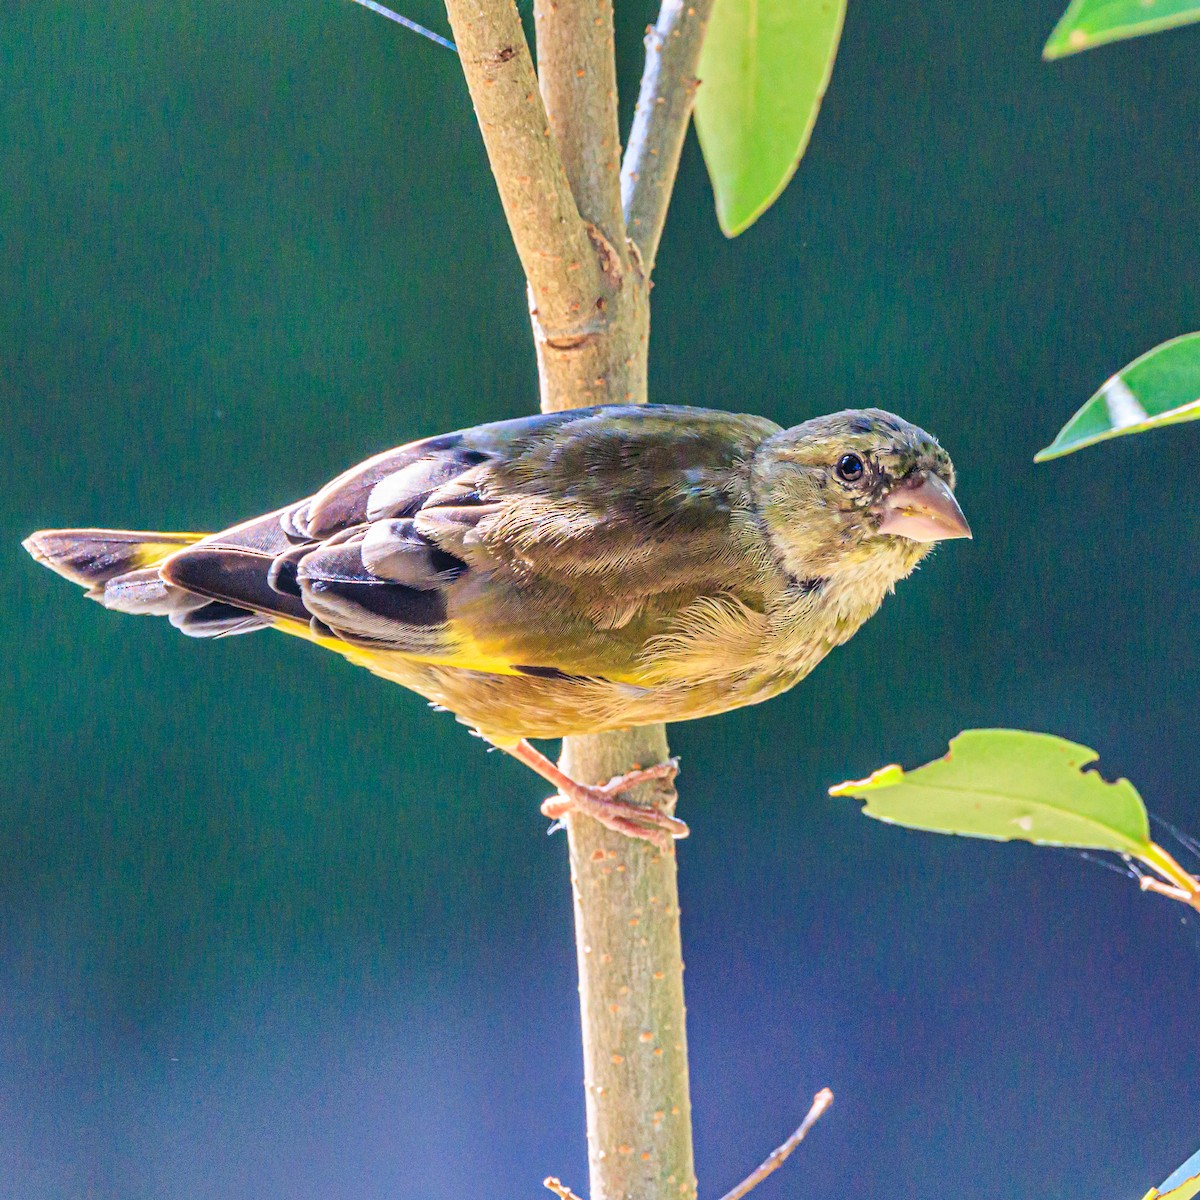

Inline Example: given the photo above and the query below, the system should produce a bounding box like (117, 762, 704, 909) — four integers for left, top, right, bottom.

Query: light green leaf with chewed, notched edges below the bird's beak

(829, 730, 1151, 857)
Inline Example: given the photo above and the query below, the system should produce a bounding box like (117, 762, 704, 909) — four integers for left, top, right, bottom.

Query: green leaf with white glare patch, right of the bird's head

(1033, 334, 1200, 462)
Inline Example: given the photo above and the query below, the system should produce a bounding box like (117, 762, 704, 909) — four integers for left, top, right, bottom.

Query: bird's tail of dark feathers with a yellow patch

(22, 529, 273, 637)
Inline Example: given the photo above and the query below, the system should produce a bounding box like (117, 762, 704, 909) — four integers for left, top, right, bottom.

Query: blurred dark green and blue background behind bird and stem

(0, 0, 1200, 1200)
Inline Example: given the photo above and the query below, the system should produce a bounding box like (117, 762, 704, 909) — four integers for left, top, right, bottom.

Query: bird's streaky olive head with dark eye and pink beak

(754, 408, 971, 586)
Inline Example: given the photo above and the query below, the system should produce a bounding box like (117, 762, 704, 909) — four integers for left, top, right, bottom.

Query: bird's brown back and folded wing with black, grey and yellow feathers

(163, 406, 778, 674)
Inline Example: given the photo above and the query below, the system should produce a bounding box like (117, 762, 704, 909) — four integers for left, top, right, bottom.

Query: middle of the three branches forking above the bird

(533, 0, 626, 253)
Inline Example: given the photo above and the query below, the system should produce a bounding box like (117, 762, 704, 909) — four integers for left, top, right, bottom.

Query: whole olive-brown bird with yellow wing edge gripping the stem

(24, 404, 971, 851)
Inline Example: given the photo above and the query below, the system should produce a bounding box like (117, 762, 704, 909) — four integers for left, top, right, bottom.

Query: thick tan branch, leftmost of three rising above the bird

(446, 0, 612, 338)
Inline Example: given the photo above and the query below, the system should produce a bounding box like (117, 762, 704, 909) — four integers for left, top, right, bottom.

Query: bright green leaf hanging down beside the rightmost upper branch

(696, 0, 846, 238)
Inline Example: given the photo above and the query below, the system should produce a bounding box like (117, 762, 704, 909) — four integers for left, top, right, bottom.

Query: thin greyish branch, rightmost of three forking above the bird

(620, 0, 713, 275)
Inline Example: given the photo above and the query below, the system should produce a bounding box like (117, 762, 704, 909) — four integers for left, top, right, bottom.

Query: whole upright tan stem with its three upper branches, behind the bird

(436, 0, 712, 1200)
